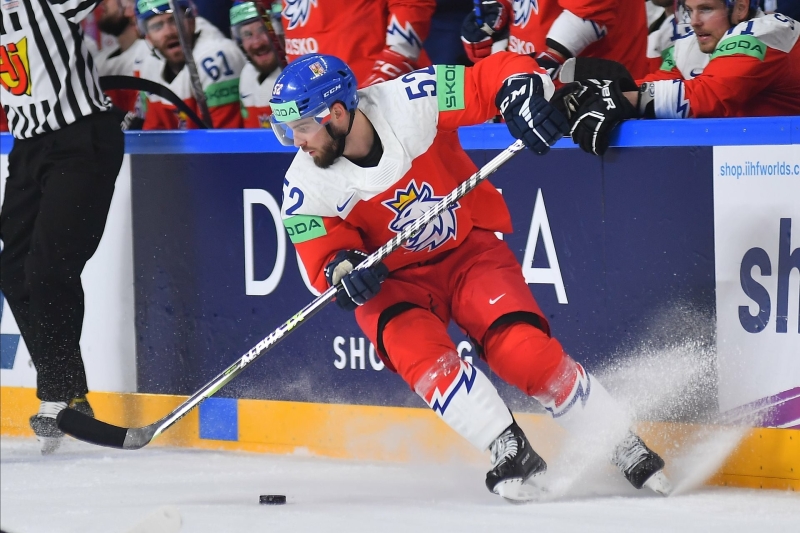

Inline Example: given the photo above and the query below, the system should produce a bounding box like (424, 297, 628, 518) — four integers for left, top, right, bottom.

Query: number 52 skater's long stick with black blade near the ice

(57, 137, 524, 450)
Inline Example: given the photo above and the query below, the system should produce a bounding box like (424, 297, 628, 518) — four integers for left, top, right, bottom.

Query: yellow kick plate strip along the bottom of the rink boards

(0, 387, 800, 491)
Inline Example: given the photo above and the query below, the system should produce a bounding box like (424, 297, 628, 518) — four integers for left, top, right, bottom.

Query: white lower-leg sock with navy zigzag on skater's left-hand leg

(414, 350, 514, 451)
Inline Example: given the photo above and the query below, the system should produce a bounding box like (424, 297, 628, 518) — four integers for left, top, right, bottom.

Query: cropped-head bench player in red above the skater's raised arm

(461, 0, 648, 79)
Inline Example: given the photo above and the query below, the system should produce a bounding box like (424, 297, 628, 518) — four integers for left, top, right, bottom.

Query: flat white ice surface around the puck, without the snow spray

(0, 438, 800, 533)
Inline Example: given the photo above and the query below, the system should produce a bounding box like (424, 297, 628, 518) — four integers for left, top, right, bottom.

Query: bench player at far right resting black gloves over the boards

(555, 0, 800, 154)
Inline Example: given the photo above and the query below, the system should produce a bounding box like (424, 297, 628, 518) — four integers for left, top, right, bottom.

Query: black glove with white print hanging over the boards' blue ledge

(550, 79, 638, 155)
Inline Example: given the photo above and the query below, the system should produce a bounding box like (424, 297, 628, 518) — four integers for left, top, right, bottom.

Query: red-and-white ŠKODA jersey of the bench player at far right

(644, 13, 800, 118)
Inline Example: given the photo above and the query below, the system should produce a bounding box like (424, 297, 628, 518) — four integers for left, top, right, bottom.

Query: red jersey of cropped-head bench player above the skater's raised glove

(501, 0, 648, 78)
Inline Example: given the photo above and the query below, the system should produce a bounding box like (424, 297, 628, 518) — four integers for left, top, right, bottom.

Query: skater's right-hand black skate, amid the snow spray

(612, 433, 672, 496)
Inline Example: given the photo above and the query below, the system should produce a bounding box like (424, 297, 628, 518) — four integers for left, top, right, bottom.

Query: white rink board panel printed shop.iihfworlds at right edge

(714, 145, 800, 411)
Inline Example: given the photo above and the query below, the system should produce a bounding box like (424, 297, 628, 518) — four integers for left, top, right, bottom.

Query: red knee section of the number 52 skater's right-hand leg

(484, 322, 567, 396)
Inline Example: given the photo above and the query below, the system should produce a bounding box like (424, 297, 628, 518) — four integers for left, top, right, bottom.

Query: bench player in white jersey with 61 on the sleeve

(136, 0, 247, 130)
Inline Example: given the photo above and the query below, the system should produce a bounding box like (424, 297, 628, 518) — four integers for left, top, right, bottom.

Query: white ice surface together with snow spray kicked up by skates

(0, 309, 800, 533)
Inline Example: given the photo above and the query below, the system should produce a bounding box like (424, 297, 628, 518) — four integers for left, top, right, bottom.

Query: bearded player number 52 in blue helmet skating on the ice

(270, 52, 666, 501)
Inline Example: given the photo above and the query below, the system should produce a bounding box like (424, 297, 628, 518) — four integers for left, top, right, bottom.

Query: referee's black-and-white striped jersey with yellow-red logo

(0, 0, 111, 139)
